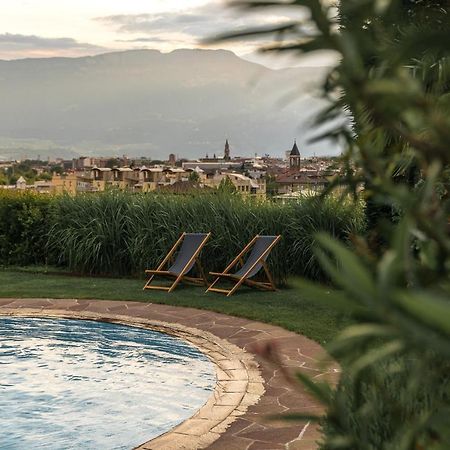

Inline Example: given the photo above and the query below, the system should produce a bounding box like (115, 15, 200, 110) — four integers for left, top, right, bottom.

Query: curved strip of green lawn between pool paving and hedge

(0, 269, 350, 344)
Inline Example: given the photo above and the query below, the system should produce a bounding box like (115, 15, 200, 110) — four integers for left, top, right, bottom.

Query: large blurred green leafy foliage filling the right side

(220, 0, 450, 450)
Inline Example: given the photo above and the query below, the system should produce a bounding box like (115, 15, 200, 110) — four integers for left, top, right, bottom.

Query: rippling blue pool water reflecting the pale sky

(0, 317, 216, 450)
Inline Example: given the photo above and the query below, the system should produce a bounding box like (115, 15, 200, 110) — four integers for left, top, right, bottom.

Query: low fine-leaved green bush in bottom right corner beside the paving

(321, 357, 450, 450)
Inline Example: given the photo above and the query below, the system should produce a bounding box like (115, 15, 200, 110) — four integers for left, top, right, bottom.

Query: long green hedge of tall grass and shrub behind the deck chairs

(0, 190, 364, 282)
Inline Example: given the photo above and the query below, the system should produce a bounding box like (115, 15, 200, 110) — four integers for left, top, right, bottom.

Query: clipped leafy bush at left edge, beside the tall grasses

(0, 190, 51, 265)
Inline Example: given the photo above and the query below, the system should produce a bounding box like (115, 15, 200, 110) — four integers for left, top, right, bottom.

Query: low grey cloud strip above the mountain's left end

(0, 33, 107, 57)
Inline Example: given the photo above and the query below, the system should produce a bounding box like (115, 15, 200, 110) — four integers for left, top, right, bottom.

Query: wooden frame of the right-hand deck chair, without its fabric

(206, 234, 281, 297)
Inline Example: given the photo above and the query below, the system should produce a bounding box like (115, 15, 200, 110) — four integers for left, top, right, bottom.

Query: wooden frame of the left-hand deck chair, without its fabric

(143, 233, 211, 292)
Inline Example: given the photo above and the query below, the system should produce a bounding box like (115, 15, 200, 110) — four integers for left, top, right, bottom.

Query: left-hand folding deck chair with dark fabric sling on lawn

(144, 233, 211, 292)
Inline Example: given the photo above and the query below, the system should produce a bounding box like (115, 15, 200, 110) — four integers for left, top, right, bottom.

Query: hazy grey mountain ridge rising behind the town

(0, 50, 336, 159)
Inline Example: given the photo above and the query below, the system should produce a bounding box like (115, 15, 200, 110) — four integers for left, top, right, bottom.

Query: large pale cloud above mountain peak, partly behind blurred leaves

(94, 0, 334, 68)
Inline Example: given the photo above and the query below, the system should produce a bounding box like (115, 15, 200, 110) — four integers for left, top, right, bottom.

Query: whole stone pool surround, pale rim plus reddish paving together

(0, 299, 339, 450)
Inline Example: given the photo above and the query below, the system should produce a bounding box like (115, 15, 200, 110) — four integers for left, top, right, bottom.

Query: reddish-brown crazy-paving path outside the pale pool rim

(0, 299, 338, 450)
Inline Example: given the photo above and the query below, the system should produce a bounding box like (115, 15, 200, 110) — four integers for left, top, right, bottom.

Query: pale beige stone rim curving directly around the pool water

(0, 308, 265, 450)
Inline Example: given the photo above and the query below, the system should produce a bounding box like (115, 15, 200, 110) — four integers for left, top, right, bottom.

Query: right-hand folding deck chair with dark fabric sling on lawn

(206, 235, 281, 297)
